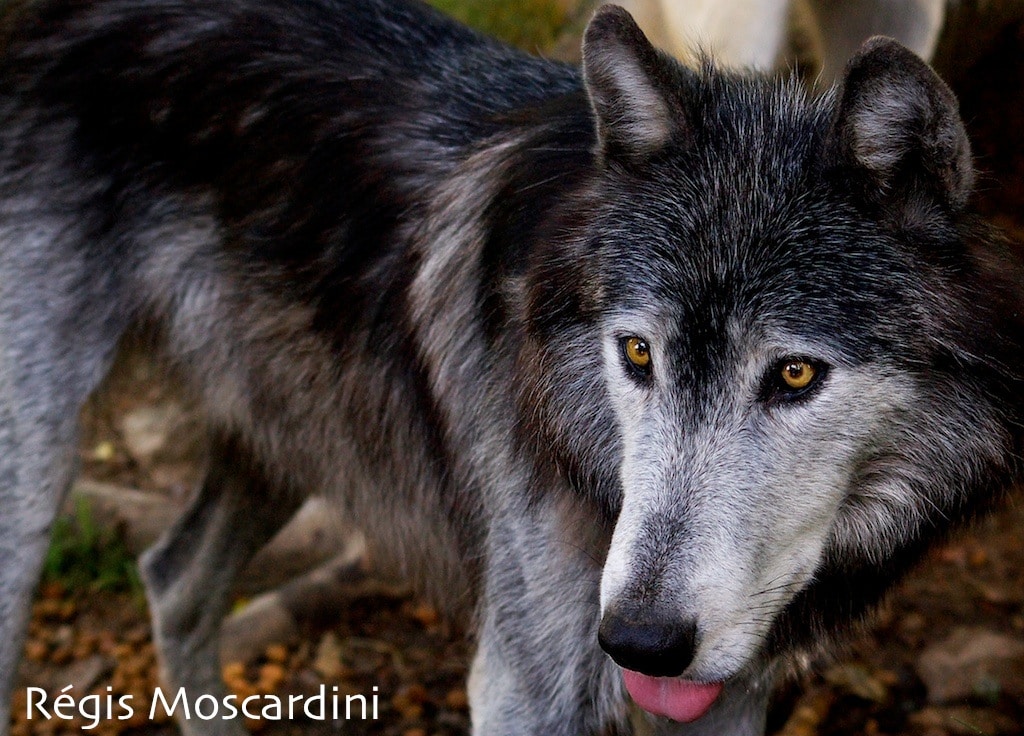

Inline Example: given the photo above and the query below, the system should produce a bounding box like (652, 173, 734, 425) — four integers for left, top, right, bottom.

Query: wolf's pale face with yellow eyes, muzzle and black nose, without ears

(601, 195, 927, 681)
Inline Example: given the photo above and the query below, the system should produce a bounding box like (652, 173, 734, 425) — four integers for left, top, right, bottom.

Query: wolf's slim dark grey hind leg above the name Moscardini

(140, 431, 301, 735)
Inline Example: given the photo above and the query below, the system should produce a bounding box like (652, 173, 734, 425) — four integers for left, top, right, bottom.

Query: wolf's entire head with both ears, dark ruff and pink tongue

(520, 2, 1020, 719)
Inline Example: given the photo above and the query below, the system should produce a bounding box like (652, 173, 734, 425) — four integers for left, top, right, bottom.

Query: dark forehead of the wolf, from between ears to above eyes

(598, 82, 915, 359)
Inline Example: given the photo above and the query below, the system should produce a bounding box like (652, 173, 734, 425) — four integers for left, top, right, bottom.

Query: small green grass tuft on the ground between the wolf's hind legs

(43, 499, 142, 598)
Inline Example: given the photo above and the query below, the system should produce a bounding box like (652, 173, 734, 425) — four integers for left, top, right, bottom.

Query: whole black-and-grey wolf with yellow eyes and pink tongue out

(0, 0, 1024, 736)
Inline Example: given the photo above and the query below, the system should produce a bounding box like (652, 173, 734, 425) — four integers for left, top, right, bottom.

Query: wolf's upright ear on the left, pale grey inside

(583, 5, 683, 161)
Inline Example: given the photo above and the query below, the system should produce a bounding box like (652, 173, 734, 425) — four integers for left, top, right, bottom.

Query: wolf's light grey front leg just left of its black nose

(469, 510, 626, 736)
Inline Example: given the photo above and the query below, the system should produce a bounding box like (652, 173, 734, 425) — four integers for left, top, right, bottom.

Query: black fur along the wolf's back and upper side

(4, 1, 588, 331)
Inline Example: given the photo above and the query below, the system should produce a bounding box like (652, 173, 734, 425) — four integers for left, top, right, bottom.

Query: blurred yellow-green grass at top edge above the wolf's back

(429, 0, 569, 51)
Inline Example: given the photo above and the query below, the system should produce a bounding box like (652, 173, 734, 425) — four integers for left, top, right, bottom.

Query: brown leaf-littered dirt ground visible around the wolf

(13, 12, 1024, 736)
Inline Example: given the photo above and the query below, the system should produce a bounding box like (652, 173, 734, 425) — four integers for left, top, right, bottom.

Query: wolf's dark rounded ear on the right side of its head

(831, 36, 974, 210)
